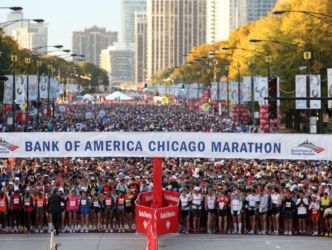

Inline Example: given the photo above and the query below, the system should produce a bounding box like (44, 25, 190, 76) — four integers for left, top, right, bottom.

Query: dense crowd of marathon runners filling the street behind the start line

(0, 104, 332, 237)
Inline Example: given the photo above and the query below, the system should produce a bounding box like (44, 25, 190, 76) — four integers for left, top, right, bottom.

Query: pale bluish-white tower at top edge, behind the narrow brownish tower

(121, 0, 146, 43)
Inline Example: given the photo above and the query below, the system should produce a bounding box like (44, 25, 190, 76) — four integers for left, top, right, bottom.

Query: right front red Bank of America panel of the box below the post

(156, 206, 179, 236)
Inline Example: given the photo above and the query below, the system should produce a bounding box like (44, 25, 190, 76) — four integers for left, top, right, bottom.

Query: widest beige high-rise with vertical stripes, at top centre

(147, 0, 206, 77)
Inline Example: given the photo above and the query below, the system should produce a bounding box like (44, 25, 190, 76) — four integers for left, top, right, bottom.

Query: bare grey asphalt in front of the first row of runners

(0, 233, 332, 250)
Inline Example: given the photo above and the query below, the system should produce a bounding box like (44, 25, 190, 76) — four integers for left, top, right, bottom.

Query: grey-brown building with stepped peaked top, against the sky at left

(72, 26, 118, 66)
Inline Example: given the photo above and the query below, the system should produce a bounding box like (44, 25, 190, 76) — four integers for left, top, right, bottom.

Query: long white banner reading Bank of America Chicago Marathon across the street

(0, 132, 332, 160)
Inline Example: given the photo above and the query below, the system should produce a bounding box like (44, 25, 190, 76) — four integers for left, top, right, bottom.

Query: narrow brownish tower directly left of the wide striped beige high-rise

(135, 11, 147, 87)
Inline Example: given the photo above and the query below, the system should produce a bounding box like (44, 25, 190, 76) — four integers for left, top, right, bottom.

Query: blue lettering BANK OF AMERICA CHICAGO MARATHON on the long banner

(25, 140, 281, 154)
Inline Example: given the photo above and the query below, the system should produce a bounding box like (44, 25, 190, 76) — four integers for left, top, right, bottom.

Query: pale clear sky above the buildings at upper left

(0, 0, 121, 50)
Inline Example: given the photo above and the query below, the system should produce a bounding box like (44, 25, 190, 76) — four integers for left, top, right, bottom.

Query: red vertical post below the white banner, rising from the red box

(153, 157, 163, 209)
